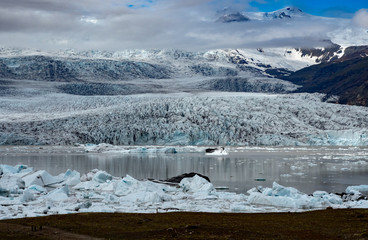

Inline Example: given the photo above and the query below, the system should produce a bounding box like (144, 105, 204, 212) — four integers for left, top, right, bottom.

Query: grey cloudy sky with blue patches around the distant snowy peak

(0, 0, 368, 50)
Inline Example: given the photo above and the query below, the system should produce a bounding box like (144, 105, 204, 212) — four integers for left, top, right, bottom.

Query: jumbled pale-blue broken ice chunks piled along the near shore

(0, 165, 368, 219)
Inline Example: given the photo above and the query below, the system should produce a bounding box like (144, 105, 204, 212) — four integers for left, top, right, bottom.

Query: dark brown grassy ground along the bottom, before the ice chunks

(0, 209, 368, 239)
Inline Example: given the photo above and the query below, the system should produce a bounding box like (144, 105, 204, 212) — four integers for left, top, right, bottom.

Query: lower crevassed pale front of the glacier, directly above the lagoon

(0, 92, 368, 145)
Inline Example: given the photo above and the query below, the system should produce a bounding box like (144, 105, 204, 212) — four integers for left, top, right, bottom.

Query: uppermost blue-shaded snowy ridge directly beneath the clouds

(0, 45, 348, 82)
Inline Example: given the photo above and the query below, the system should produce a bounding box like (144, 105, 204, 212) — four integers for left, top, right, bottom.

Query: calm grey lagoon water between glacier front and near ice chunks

(0, 149, 368, 193)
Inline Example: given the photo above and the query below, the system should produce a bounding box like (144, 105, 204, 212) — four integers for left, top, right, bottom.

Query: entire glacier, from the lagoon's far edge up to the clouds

(0, 44, 368, 146)
